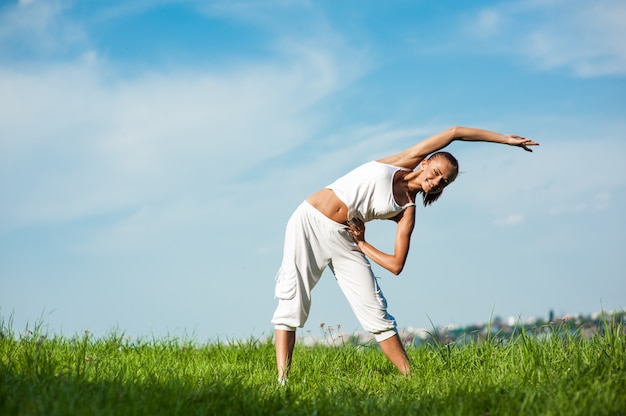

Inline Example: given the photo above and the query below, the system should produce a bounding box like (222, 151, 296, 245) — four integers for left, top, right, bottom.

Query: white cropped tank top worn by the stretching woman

(326, 162, 415, 222)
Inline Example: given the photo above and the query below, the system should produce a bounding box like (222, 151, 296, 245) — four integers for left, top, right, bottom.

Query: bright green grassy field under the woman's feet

(0, 316, 626, 415)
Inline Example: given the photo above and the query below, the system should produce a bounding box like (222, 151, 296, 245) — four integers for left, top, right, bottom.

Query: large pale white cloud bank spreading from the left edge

(0, 41, 360, 234)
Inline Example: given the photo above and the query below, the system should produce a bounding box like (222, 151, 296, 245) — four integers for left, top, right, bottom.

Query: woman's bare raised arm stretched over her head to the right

(378, 126, 539, 170)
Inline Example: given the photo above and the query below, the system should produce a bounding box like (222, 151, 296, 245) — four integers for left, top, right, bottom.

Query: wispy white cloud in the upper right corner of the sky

(468, 0, 626, 77)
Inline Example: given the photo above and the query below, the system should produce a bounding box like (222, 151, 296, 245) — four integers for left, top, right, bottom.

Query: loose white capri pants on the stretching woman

(272, 201, 397, 342)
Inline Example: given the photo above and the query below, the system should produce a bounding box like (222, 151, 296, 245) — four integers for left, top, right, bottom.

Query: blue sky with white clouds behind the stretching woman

(0, 0, 626, 341)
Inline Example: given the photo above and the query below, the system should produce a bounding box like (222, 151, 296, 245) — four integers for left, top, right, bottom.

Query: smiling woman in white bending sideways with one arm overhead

(272, 127, 538, 383)
